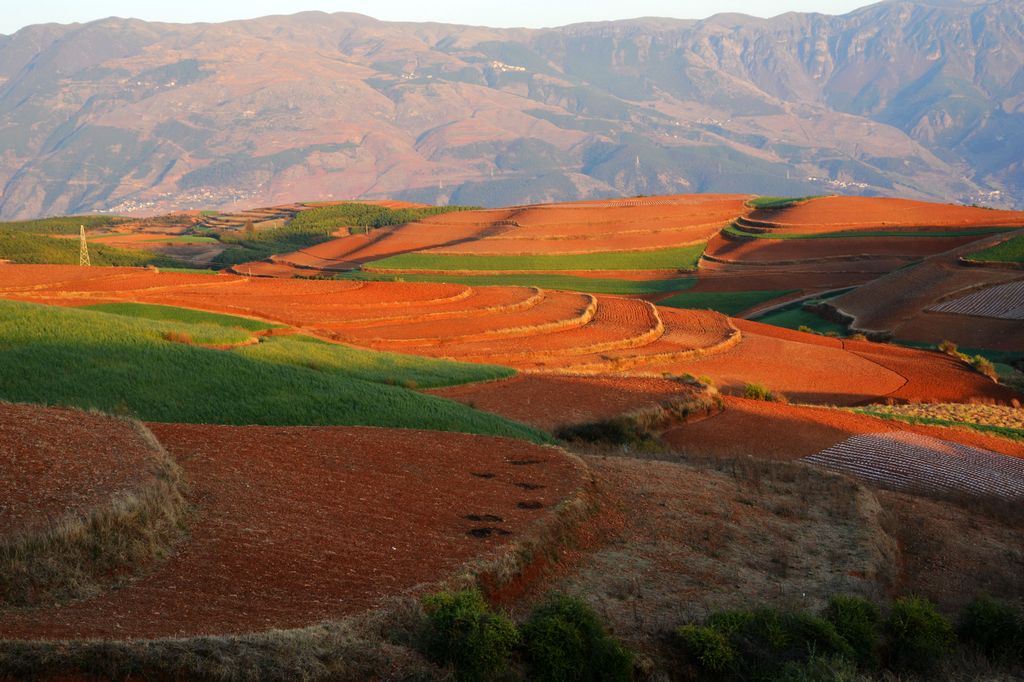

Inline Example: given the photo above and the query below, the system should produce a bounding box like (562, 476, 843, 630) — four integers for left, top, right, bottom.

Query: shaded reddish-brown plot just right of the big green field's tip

(429, 374, 689, 430)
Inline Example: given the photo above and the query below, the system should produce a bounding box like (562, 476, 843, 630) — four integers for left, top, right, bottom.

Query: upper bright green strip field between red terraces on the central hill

(366, 244, 705, 271)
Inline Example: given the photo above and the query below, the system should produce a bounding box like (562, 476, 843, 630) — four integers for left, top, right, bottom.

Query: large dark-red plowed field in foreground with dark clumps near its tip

(0, 424, 581, 639)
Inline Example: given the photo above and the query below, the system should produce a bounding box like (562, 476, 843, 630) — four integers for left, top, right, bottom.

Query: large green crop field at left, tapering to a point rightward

(0, 301, 550, 442)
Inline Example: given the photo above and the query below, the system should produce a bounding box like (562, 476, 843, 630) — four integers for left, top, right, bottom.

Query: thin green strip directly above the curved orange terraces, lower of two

(336, 270, 696, 296)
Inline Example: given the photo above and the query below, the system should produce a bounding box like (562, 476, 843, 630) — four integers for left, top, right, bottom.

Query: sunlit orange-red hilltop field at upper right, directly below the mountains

(751, 197, 1024, 233)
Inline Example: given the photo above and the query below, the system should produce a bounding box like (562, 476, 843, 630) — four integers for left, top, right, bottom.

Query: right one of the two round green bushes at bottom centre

(522, 596, 633, 682)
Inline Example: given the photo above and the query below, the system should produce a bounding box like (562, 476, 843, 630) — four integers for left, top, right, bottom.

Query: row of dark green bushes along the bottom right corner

(675, 595, 1024, 680)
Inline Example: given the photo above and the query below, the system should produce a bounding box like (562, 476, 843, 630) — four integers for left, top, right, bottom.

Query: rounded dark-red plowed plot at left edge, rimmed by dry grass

(0, 402, 156, 537)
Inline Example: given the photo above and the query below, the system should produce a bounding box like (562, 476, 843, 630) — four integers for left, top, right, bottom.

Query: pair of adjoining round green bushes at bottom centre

(418, 590, 633, 682)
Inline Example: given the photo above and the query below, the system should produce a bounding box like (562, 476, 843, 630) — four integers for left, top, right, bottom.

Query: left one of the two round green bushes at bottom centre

(423, 590, 519, 680)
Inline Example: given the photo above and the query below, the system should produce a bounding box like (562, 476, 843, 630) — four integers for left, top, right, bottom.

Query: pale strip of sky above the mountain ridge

(0, 0, 872, 34)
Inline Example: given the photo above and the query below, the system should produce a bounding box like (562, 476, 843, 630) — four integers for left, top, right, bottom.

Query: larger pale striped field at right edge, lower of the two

(803, 433, 1024, 500)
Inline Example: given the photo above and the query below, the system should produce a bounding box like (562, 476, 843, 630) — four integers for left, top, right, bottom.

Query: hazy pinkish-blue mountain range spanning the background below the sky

(0, 0, 1024, 218)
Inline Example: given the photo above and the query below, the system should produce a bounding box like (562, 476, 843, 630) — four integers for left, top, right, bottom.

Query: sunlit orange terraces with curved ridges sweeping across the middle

(0, 266, 1012, 404)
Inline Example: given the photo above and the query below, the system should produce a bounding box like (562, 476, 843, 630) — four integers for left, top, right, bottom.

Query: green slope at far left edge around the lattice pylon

(0, 230, 181, 267)
